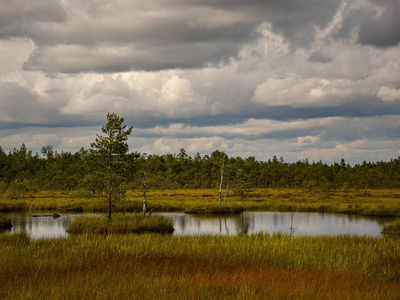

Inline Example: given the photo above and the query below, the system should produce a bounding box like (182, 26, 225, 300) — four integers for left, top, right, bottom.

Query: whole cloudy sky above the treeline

(0, 0, 400, 164)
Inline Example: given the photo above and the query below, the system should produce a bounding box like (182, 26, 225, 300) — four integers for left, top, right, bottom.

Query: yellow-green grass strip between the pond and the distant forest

(0, 189, 400, 217)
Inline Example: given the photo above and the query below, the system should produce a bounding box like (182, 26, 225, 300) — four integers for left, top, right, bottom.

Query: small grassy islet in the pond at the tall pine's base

(67, 215, 174, 234)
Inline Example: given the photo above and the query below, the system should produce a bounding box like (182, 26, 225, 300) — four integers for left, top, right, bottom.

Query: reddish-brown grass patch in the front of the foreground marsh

(0, 258, 400, 299)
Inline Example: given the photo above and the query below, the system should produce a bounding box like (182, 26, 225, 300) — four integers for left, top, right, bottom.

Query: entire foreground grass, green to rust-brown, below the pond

(0, 233, 400, 299)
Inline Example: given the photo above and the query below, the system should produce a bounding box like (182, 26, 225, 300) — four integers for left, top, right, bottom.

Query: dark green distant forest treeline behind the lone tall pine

(0, 144, 400, 198)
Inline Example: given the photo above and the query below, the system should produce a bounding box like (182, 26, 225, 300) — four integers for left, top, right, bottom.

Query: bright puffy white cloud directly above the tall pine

(60, 72, 208, 118)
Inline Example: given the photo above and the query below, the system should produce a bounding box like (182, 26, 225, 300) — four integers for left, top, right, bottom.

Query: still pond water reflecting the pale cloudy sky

(4, 212, 390, 239)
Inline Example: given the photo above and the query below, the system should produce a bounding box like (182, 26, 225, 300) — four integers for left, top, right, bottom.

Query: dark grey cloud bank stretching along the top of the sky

(0, 0, 400, 73)
